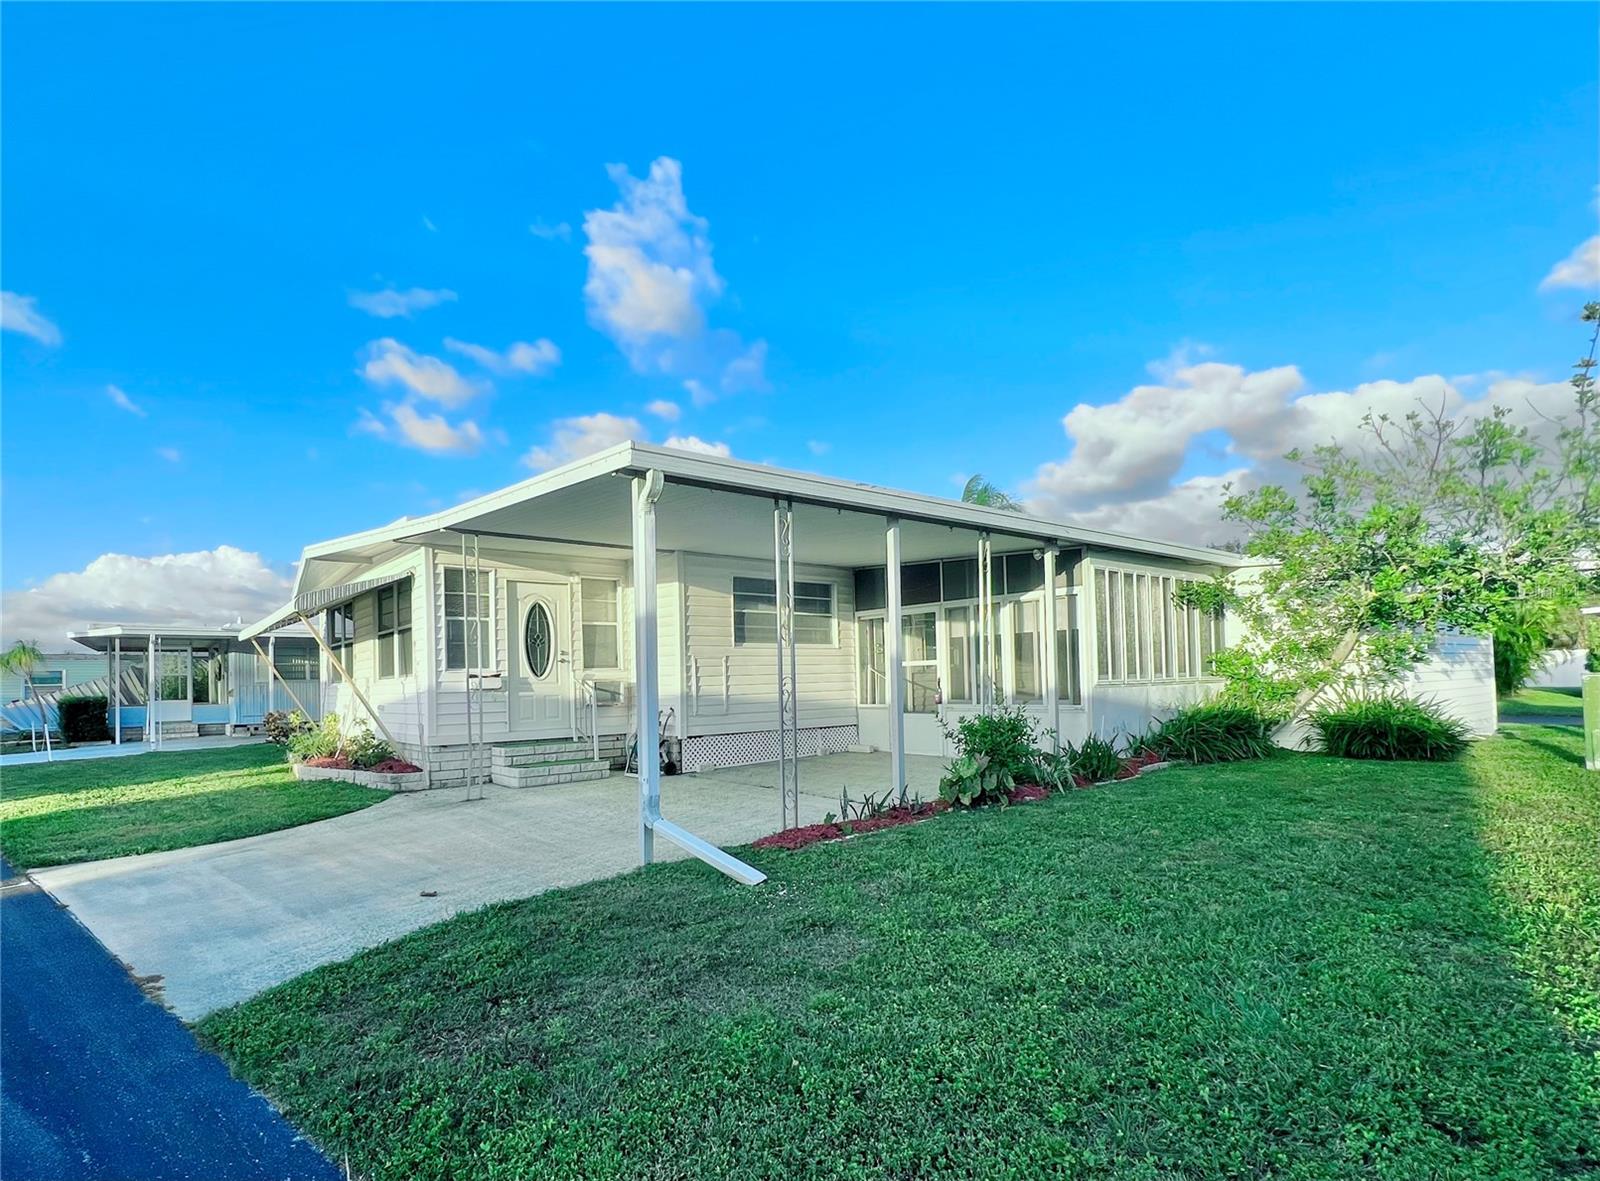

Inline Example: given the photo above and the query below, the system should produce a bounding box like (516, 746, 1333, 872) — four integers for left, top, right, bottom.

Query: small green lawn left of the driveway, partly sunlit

(0, 744, 386, 869)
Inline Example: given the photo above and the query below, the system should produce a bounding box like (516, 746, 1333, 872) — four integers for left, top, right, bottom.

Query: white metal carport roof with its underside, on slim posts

(281, 443, 1240, 608)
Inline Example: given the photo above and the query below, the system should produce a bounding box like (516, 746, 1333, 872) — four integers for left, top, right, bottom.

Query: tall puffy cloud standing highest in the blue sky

(584, 157, 766, 397)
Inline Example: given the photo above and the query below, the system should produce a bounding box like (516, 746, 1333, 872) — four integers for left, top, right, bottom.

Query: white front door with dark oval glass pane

(506, 581, 573, 738)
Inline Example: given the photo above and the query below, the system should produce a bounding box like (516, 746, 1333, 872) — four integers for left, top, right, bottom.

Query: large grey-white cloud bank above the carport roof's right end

(1024, 352, 1571, 542)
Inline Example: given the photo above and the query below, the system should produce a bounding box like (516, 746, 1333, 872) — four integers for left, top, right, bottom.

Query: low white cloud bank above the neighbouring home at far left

(0, 546, 290, 651)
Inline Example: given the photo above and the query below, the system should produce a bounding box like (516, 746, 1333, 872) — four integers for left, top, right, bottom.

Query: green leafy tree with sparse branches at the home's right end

(1192, 304, 1600, 717)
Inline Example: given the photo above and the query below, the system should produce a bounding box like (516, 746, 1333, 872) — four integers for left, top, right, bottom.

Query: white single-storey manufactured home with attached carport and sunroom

(243, 443, 1238, 787)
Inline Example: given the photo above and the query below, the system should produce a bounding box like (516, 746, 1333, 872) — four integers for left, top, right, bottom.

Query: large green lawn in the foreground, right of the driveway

(200, 727, 1600, 1181)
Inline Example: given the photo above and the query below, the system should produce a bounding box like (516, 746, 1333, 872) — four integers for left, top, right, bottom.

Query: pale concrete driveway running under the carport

(34, 755, 939, 1021)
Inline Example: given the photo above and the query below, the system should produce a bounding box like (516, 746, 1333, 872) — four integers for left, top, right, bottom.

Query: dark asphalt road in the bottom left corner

(0, 861, 342, 1181)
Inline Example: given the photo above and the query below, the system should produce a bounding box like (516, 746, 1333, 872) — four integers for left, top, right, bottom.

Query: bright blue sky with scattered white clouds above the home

(0, 5, 1600, 634)
